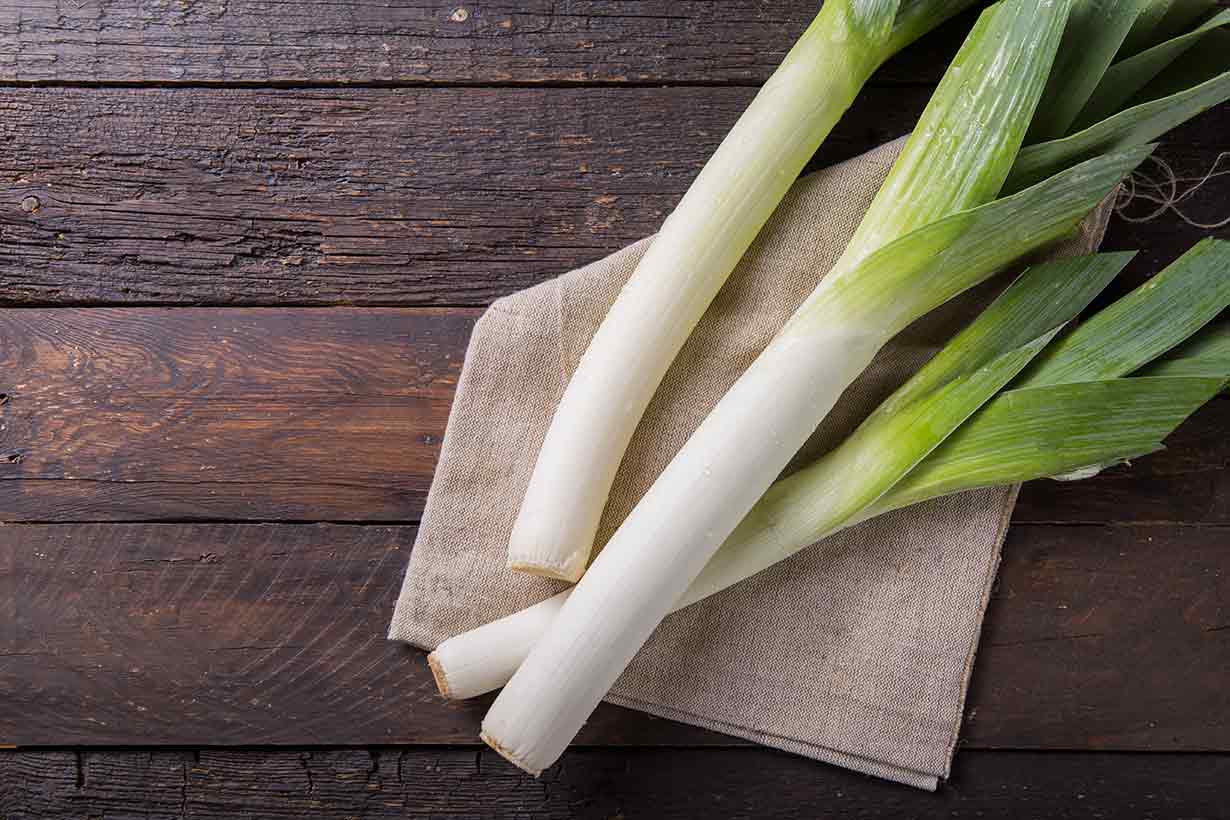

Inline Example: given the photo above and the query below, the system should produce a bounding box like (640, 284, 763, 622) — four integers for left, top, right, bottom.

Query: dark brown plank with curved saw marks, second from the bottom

(0, 524, 1230, 751)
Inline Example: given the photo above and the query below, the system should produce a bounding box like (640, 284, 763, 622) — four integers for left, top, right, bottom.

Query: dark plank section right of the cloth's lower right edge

(963, 525, 1230, 750)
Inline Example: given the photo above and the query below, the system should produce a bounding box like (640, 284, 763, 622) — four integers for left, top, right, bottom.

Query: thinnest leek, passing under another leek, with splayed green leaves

(428, 240, 1230, 698)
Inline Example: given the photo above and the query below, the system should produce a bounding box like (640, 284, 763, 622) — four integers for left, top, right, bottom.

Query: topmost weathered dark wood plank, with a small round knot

(0, 0, 973, 84)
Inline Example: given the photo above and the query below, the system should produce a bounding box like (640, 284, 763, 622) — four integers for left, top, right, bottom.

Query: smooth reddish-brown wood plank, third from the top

(0, 307, 1230, 524)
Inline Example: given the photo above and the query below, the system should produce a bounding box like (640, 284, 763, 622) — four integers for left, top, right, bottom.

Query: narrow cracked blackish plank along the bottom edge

(0, 749, 1230, 820)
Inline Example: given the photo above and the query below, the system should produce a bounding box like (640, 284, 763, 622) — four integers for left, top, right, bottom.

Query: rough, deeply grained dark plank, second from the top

(0, 86, 1230, 305)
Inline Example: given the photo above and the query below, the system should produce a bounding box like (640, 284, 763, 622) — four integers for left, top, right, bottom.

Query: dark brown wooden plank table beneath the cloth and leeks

(0, 0, 1230, 819)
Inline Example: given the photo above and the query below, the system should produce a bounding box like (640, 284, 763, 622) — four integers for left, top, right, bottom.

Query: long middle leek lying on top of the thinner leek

(482, 0, 1087, 773)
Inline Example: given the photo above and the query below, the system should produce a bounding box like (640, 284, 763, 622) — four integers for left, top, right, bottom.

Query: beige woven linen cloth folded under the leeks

(389, 140, 1109, 789)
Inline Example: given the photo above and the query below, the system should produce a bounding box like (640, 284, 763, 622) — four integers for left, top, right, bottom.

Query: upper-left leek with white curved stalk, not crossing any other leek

(508, 0, 972, 581)
